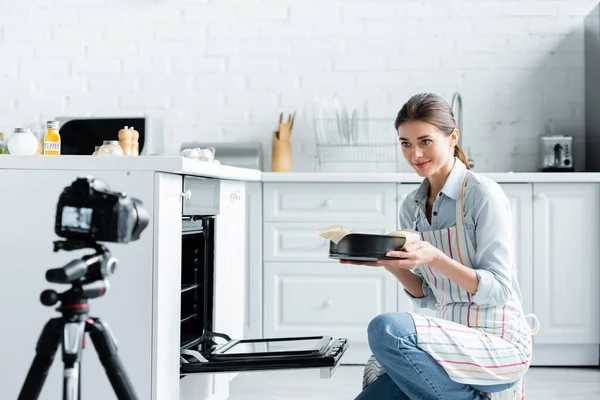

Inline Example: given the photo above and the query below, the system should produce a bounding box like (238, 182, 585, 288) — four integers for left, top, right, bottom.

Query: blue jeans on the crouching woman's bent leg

(355, 313, 516, 400)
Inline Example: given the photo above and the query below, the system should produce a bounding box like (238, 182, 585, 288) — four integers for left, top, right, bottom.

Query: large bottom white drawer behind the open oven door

(264, 262, 397, 343)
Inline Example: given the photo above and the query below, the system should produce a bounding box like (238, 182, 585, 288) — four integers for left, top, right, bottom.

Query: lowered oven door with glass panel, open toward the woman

(180, 333, 349, 379)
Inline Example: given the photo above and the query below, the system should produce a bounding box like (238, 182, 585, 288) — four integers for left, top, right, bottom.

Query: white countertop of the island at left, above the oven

(0, 155, 261, 181)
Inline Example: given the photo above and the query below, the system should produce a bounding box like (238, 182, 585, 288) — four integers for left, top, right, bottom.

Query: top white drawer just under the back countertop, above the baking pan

(263, 183, 396, 224)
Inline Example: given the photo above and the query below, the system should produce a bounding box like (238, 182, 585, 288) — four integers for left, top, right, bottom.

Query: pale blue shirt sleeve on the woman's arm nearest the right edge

(471, 181, 514, 306)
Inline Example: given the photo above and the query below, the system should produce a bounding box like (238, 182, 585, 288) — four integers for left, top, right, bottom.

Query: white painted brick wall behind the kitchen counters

(0, 0, 595, 171)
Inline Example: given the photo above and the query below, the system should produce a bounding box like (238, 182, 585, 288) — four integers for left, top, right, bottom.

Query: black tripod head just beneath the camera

(40, 239, 117, 314)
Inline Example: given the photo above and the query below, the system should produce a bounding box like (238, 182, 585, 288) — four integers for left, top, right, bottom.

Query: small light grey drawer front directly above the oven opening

(183, 176, 220, 215)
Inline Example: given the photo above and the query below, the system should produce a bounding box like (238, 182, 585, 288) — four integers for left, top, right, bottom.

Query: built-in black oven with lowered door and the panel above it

(180, 178, 349, 378)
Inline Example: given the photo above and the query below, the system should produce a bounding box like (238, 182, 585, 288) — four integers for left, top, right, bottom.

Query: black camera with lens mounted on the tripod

(54, 176, 148, 243)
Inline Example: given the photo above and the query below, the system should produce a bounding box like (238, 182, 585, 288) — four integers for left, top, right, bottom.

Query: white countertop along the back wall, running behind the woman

(262, 172, 600, 183)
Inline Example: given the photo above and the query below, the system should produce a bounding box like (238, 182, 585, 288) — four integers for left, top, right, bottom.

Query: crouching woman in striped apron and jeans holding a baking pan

(341, 93, 534, 400)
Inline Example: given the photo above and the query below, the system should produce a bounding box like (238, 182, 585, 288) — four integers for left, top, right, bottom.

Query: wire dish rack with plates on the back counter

(314, 118, 401, 172)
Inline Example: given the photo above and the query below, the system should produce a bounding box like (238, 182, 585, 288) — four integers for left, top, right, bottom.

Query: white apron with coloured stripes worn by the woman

(363, 176, 537, 400)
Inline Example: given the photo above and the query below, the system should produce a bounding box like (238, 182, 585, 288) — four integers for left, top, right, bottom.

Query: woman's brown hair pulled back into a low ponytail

(394, 93, 470, 169)
